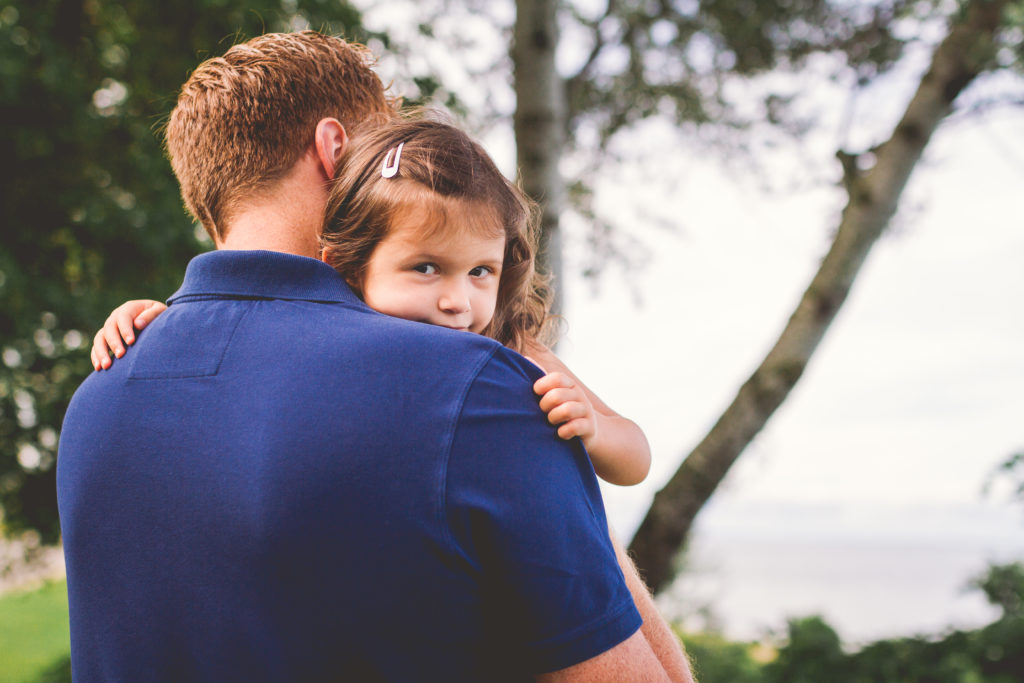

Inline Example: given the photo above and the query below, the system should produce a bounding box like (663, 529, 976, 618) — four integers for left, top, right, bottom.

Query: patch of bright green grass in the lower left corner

(0, 581, 71, 683)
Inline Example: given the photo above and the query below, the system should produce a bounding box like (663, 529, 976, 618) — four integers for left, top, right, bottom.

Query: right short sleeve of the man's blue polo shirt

(445, 349, 641, 674)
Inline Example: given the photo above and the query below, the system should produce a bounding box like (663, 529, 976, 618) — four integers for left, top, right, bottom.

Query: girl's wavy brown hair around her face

(322, 113, 552, 352)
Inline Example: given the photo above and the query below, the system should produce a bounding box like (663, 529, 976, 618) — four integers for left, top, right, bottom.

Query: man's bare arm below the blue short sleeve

(537, 536, 694, 683)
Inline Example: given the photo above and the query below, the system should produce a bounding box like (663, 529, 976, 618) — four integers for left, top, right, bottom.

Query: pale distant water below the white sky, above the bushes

(614, 504, 1024, 645)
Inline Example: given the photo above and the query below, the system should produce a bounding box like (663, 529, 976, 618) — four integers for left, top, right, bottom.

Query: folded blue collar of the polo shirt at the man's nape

(167, 250, 359, 304)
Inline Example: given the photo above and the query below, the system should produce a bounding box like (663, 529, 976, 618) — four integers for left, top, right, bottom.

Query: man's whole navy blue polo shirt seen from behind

(57, 252, 640, 681)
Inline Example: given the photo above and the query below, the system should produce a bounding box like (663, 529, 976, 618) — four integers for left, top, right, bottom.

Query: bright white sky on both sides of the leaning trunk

(562, 109, 1024, 524)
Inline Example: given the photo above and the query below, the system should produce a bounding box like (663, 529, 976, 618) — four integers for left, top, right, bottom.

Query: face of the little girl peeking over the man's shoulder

(361, 201, 505, 334)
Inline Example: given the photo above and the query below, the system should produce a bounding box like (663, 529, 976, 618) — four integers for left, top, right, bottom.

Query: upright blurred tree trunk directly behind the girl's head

(512, 0, 566, 312)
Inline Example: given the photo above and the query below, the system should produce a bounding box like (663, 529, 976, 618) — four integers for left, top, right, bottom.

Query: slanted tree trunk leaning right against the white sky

(630, 0, 1006, 591)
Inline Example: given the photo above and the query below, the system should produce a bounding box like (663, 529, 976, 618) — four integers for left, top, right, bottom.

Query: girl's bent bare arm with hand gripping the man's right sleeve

(526, 342, 650, 486)
